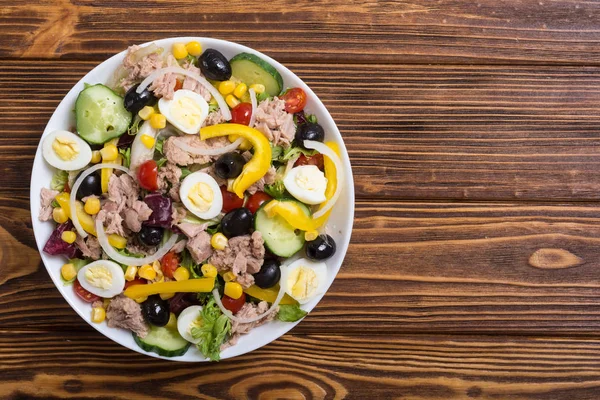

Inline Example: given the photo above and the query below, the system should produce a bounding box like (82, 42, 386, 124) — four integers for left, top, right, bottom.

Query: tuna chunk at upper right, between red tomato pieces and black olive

(254, 96, 296, 147)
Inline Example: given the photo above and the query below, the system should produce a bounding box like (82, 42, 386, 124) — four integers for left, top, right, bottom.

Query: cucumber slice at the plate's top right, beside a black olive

(229, 53, 283, 96)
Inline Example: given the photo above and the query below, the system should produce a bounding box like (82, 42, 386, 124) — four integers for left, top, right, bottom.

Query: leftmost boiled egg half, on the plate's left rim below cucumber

(42, 130, 92, 171)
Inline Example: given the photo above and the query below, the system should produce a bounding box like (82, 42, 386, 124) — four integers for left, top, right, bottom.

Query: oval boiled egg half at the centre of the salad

(179, 171, 223, 219)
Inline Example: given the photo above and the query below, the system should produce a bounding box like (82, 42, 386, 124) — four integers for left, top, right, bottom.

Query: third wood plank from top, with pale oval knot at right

(9, 198, 600, 335)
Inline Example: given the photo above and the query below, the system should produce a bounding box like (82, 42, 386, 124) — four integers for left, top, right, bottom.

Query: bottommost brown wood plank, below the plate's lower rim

(0, 330, 600, 400)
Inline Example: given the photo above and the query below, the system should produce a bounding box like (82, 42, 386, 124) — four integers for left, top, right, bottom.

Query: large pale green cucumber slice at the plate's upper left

(75, 84, 132, 144)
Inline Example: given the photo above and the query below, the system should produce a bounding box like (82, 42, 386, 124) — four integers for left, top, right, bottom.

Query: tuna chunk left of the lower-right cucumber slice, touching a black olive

(209, 231, 265, 289)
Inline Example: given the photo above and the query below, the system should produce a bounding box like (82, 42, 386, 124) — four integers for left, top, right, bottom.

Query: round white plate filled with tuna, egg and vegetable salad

(31, 38, 353, 361)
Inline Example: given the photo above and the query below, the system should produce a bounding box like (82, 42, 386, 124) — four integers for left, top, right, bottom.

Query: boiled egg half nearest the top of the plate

(158, 89, 208, 135)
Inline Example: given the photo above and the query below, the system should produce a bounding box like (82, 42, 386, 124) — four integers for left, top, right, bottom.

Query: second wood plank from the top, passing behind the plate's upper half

(0, 61, 600, 201)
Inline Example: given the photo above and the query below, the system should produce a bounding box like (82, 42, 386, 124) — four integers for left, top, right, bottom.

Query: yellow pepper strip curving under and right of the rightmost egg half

(265, 142, 340, 231)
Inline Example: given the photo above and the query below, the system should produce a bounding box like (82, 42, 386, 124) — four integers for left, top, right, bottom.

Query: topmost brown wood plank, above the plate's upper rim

(0, 0, 600, 65)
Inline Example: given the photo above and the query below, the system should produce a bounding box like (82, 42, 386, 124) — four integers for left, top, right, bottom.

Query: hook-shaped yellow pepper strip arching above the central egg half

(200, 124, 271, 199)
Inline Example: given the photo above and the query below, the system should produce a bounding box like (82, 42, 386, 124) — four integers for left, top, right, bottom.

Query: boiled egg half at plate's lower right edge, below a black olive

(280, 258, 327, 304)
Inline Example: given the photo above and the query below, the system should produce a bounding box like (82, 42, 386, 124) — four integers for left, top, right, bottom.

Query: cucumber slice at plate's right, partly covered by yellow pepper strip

(254, 200, 310, 257)
